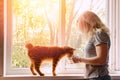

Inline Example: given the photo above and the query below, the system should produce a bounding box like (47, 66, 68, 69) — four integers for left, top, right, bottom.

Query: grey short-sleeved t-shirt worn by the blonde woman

(84, 31, 110, 78)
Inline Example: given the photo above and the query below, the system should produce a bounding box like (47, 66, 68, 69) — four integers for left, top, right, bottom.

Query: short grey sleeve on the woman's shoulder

(94, 31, 109, 46)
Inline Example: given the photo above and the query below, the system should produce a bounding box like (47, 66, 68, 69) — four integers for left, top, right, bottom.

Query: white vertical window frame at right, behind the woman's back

(107, 0, 120, 73)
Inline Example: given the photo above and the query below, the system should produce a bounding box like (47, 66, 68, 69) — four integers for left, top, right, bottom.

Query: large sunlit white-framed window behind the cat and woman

(4, 0, 120, 75)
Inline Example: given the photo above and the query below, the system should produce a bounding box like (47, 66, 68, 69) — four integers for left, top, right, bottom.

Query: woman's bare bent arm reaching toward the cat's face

(72, 44, 108, 65)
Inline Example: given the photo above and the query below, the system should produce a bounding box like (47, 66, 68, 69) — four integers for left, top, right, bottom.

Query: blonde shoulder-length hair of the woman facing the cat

(77, 11, 109, 38)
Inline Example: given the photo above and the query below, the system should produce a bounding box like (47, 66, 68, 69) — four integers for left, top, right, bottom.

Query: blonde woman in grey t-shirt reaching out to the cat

(72, 11, 111, 80)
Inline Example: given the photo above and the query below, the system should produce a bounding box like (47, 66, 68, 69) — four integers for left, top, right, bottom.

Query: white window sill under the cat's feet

(0, 74, 120, 80)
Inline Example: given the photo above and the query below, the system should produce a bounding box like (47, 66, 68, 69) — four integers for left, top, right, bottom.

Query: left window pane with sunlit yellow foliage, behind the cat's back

(11, 0, 59, 68)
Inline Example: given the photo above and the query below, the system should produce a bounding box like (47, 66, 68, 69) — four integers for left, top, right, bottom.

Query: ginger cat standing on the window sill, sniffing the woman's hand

(26, 43, 75, 76)
